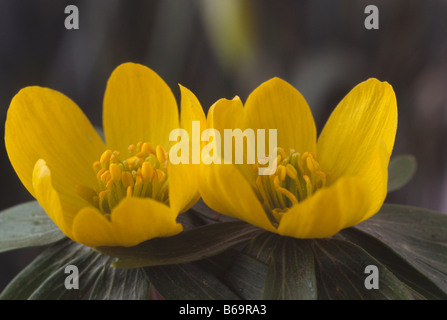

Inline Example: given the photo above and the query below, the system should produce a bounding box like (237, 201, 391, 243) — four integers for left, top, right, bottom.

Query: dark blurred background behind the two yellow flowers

(0, 0, 447, 291)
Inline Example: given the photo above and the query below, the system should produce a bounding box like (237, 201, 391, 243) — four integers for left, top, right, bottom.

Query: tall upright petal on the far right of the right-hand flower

(317, 79, 397, 182)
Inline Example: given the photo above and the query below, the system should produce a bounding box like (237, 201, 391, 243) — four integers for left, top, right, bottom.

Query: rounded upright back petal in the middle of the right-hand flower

(244, 78, 317, 153)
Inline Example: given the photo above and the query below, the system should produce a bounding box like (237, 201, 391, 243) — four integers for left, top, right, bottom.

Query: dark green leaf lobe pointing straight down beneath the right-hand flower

(263, 236, 317, 300)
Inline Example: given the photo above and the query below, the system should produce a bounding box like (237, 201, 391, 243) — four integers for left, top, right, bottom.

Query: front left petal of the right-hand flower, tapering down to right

(199, 164, 276, 232)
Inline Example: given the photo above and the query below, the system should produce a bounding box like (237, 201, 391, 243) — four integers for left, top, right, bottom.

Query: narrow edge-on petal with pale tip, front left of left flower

(32, 159, 79, 238)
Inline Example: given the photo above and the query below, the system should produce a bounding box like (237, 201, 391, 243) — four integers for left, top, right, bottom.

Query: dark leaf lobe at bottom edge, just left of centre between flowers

(144, 263, 239, 300)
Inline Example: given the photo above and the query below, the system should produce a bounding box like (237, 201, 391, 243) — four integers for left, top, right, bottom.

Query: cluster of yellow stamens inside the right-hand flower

(255, 148, 326, 226)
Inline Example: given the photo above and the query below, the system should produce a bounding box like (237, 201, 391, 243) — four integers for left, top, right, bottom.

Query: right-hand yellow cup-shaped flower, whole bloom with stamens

(199, 78, 397, 238)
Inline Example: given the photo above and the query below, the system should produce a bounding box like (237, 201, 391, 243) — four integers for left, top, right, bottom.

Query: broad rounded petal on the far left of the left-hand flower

(5, 87, 105, 202)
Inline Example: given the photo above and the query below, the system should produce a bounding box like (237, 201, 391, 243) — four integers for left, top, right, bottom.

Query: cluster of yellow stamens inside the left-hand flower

(78, 142, 169, 215)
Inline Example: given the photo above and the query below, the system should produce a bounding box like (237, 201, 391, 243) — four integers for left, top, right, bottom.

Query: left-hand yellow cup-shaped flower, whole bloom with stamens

(5, 63, 205, 247)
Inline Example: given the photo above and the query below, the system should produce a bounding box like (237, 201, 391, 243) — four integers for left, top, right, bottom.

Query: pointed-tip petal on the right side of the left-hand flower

(168, 86, 207, 212)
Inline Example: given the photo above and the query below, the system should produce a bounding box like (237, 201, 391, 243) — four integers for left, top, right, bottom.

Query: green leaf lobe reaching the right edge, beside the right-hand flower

(355, 204, 447, 293)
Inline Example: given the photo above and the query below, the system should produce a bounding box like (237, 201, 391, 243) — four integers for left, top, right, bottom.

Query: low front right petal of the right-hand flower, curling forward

(278, 177, 370, 238)
